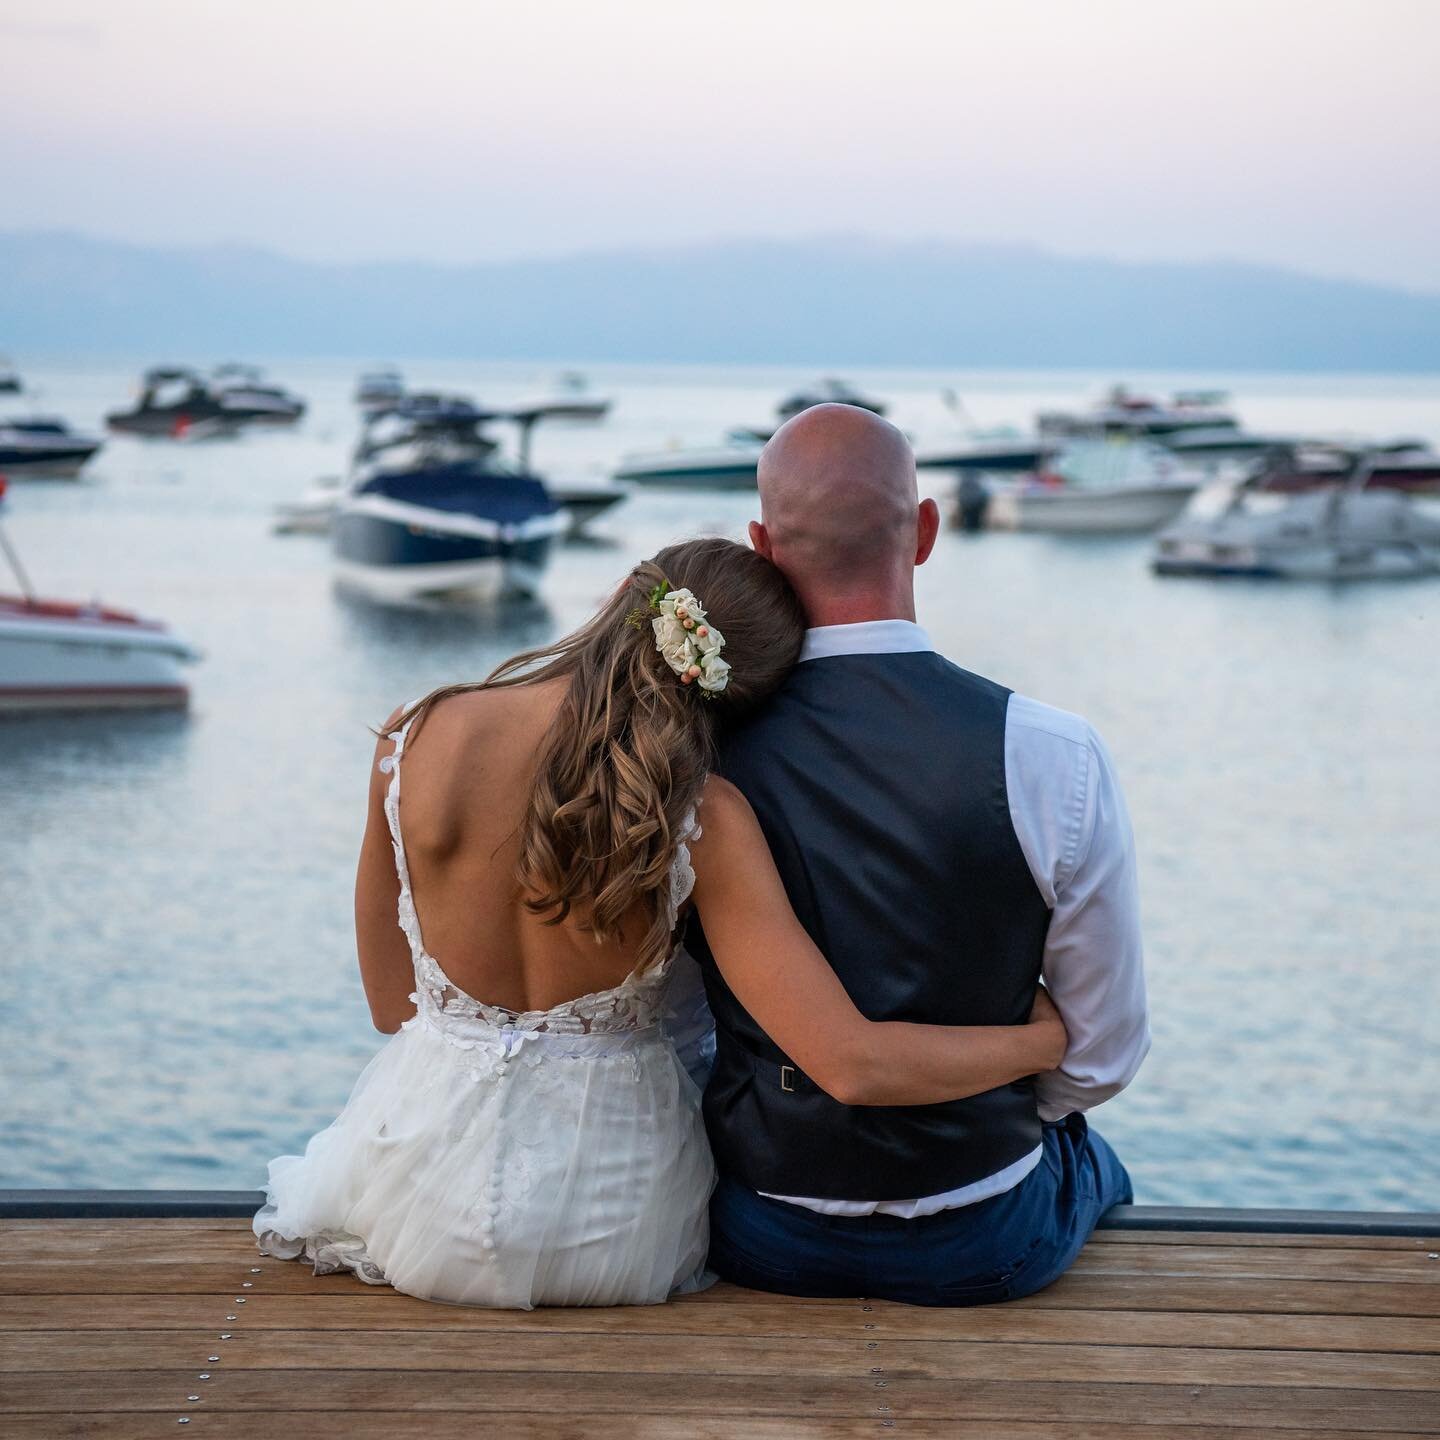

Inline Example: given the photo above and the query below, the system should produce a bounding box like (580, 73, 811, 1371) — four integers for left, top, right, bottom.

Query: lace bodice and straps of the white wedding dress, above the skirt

(380, 706, 700, 1035)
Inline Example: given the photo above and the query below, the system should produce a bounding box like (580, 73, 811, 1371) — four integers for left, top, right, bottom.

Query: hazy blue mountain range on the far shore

(0, 232, 1440, 372)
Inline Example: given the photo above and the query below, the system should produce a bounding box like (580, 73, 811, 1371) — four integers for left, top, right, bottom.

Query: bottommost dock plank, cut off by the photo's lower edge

(6, 1407, 1424, 1440)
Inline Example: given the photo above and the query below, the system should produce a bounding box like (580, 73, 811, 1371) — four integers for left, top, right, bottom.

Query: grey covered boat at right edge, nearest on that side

(1152, 455, 1440, 580)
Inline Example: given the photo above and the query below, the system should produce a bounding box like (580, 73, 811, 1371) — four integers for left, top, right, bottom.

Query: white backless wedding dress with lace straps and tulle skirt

(255, 708, 714, 1309)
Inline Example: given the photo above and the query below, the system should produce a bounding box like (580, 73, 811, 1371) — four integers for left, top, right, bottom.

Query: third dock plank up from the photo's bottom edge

(0, 1331, 1440, 1388)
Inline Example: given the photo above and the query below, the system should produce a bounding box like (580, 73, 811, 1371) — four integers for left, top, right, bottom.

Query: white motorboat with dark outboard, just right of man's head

(984, 441, 1205, 534)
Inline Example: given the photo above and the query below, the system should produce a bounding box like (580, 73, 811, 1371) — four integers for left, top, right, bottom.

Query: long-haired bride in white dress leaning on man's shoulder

(255, 540, 1066, 1309)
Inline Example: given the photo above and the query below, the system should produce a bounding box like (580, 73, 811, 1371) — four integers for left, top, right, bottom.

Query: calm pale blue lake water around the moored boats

(0, 361, 1440, 1210)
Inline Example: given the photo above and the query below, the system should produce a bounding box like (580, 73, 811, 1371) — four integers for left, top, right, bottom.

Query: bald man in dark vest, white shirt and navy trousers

(688, 405, 1149, 1305)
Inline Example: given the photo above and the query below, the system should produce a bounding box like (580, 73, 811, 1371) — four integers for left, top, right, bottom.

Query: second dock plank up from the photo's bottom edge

(4, 1369, 1440, 1436)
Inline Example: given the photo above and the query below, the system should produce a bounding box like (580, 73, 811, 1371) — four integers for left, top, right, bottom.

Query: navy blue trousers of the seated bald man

(710, 1115, 1133, 1305)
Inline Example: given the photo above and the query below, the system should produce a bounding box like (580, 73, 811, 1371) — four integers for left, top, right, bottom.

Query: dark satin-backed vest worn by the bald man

(687, 652, 1050, 1200)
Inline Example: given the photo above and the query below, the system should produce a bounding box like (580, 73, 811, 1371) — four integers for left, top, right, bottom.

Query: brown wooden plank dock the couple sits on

(0, 1211, 1440, 1440)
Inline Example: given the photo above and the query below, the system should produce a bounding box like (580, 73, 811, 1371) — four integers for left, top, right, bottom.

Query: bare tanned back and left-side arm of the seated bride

(356, 681, 656, 1030)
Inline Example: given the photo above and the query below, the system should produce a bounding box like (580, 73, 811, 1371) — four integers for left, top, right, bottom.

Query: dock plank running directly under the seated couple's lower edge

(0, 1290, 1440, 1355)
